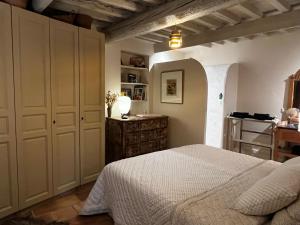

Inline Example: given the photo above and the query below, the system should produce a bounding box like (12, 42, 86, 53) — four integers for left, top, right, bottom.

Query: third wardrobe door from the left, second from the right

(50, 20, 80, 194)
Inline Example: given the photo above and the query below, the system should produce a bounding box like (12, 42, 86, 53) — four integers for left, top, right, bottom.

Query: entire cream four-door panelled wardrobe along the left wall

(0, 2, 104, 217)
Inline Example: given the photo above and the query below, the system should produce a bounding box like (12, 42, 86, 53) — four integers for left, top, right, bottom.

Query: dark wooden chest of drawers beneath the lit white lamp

(105, 116, 168, 163)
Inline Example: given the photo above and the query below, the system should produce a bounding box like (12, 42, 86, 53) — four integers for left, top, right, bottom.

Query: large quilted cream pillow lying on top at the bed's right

(234, 161, 300, 216)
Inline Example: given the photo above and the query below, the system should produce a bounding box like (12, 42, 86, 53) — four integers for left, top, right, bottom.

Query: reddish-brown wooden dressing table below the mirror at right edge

(274, 127, 300, 160)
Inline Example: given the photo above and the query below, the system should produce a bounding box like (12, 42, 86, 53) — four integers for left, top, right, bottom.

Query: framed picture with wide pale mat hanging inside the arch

(161, 70, 184, 104)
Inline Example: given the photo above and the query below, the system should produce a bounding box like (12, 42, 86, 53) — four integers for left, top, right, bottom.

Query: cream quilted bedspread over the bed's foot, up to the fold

(80, 145, 280, 225)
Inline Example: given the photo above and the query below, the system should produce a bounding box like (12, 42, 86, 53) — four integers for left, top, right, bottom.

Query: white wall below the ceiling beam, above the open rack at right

(181, 31, 300, 117)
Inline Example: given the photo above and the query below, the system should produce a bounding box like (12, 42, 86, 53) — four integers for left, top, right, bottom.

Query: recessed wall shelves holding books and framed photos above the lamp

(120, 51, 150, 115)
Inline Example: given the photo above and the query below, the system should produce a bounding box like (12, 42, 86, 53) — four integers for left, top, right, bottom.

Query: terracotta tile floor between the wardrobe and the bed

(20, 184, 114, 225)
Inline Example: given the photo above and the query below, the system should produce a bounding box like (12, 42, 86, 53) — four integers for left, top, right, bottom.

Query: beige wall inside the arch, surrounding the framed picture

(152, 59, 207, 147)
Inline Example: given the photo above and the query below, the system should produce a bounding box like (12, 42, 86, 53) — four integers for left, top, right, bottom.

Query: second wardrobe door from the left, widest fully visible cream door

(12, 7, 52, 208)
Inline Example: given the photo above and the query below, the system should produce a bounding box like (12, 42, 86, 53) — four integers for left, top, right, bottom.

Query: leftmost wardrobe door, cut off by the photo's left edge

(0, 2, 18, 218)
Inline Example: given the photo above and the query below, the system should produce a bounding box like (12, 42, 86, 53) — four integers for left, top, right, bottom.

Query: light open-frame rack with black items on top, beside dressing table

(227, 116, 276, 159)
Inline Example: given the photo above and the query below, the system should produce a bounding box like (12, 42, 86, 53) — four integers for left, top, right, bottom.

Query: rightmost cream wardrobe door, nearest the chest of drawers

(79, 28, 105, 184)
